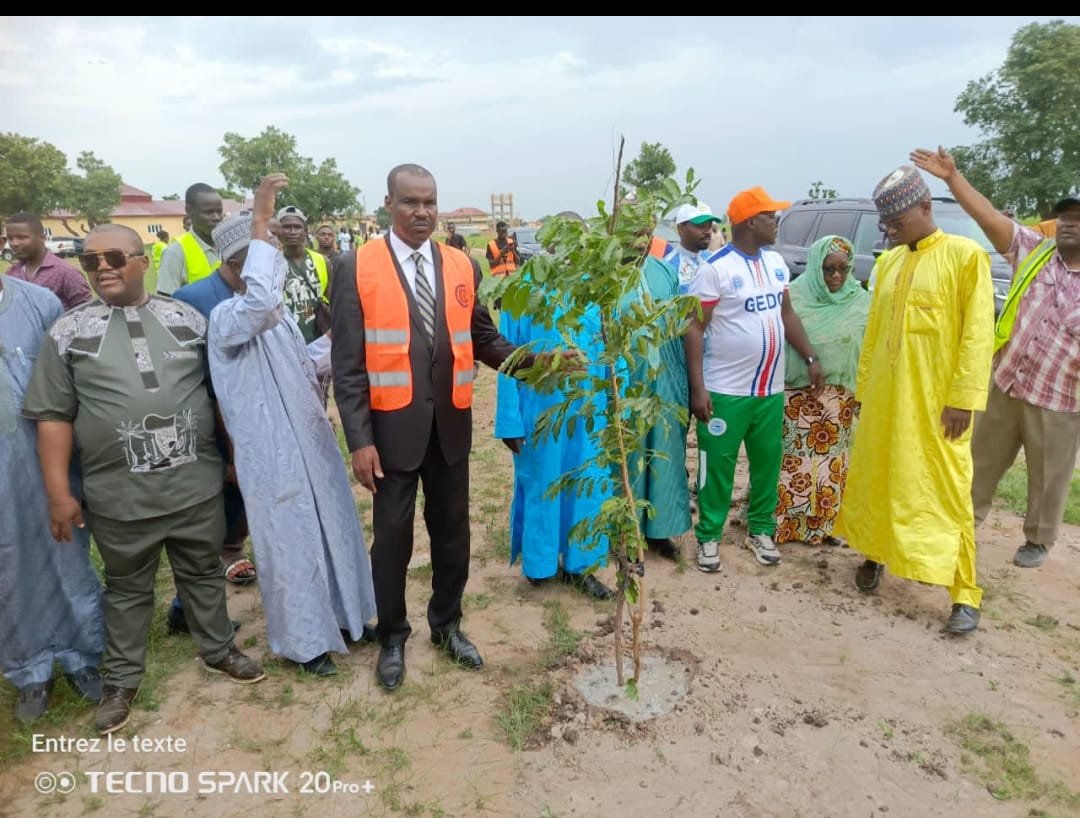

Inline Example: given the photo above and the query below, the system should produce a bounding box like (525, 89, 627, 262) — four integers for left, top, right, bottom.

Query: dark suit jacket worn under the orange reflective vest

(330, 234, 515, 471)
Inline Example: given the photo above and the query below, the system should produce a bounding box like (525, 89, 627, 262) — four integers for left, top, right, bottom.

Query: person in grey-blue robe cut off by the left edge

(0, 276, 105, 722)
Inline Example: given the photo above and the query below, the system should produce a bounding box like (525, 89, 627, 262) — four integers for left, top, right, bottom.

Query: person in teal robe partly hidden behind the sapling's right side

(631, 256, 692, 559)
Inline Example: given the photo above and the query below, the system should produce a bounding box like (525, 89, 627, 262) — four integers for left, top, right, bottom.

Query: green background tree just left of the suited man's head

(217, 125, 363, 219)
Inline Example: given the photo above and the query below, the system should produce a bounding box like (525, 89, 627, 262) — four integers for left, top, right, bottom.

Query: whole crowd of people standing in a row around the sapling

(0, 149, 1080, 734)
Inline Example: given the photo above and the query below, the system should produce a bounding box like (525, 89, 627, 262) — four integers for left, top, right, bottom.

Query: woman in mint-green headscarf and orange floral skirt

(775, 236, 870, 546)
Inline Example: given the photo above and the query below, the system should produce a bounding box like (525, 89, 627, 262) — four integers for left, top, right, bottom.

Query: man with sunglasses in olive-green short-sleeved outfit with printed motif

(23, 224, 264, 734)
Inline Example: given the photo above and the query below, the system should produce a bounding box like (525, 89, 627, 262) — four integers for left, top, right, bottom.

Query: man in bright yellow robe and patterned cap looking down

(834, 165, 994, 634)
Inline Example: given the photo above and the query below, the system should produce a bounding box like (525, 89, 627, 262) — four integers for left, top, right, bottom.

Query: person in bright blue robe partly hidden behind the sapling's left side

(495, 296, 612, 599)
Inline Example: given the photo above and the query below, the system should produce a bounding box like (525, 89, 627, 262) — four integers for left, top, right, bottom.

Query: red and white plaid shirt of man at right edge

(994, 227, 1080, 413)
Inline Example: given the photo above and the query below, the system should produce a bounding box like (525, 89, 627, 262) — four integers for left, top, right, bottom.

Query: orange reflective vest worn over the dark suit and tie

(356, 238, 475, 412)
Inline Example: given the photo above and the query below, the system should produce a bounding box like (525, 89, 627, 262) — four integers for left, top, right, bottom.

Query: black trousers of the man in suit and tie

(372, 421, 470, 645)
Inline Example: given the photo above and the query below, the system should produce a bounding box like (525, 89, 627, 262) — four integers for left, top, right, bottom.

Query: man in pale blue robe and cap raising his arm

(207, 174, 375, 675)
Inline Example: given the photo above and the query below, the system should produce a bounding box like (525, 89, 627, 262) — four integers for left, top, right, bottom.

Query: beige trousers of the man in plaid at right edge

(971, 384, 1080, 548)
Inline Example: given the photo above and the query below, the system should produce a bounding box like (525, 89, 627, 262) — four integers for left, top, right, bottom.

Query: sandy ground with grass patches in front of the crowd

(0, 371, 1080, 818)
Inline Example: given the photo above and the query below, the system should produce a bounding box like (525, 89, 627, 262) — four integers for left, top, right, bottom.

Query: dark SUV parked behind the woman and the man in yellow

(772, 197, 1012, 313)
